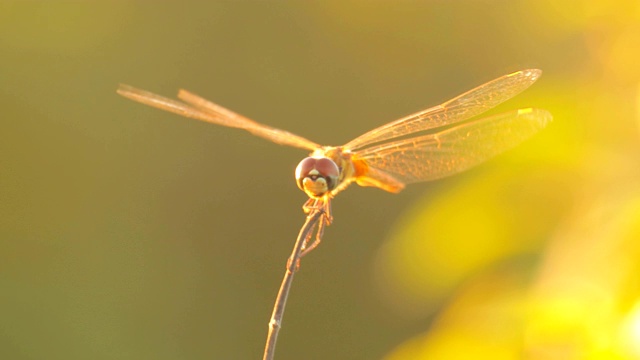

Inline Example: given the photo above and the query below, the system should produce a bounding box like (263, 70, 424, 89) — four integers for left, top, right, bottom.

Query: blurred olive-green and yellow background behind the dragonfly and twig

(0, 0, 640, 360)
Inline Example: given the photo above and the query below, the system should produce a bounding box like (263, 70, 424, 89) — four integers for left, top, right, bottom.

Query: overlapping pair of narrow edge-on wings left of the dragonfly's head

(117, 84, 320, 150)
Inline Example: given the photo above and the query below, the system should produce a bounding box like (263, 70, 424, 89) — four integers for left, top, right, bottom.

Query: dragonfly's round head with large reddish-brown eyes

(296, 156, 340, 198)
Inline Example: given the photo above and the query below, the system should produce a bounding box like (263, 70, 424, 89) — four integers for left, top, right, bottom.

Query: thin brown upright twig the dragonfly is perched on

(263, 209, 324, 360)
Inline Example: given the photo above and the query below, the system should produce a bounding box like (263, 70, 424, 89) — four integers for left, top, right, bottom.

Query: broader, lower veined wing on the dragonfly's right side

(354, 108, 552, 183)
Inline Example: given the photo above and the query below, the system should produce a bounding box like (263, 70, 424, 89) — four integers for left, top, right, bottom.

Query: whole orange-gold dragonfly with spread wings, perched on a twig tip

(117, 69, 552, 255)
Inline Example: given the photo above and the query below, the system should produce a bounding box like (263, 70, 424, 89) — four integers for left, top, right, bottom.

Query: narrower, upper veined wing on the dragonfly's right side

(344, 69, 542, 150)
